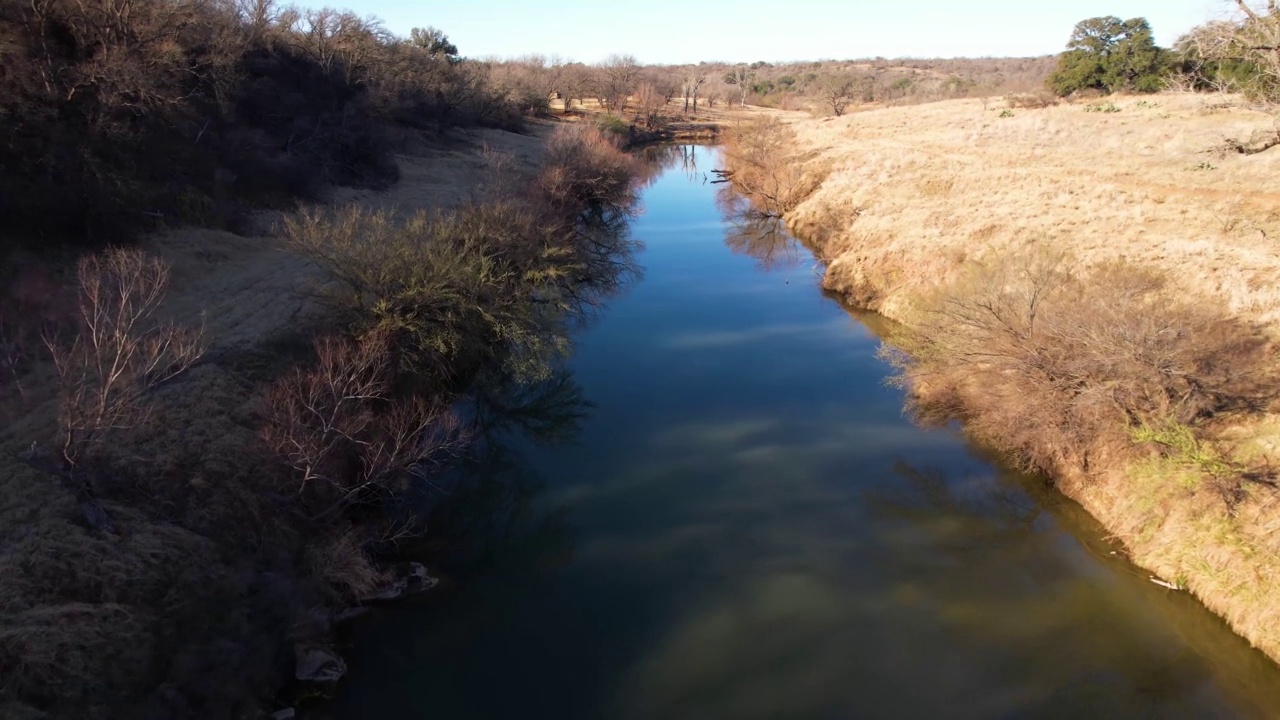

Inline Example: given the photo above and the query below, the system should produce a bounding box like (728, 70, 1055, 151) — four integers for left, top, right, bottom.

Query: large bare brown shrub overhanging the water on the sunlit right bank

(891, 250, 1274, 471)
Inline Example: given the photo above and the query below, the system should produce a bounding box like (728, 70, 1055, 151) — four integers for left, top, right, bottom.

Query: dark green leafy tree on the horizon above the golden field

(1048, 15, 1167, 95)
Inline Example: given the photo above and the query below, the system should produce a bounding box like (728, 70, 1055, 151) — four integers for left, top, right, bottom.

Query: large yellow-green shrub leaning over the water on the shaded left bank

(283, 201, 571, 379)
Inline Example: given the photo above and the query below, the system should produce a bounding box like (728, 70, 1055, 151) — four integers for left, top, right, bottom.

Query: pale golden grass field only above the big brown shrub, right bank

(787, 95, 1280, 324)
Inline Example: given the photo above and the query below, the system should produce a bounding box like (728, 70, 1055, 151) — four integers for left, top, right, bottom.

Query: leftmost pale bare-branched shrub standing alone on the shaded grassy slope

(46, 249, 205, 469)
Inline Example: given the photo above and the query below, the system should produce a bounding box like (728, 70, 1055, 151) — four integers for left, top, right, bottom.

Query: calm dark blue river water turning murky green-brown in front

(335, 147, 1280, 720)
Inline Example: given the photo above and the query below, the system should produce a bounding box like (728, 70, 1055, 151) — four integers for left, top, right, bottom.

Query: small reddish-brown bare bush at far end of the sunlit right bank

(724, 118, 831, 217)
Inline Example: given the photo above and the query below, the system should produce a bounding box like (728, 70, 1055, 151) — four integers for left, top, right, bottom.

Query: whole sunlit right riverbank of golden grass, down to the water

(752, 95, 1280, 660)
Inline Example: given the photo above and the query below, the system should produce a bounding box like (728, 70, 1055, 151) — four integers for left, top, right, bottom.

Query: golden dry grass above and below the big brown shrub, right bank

(768, 95, 1280, 660)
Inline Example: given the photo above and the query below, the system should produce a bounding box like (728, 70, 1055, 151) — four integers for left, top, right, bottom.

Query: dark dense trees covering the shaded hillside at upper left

(0, 0, 521, 242)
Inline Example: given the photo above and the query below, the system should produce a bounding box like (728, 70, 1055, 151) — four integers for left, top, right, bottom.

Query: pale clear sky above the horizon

(325, 0, 1229, 63)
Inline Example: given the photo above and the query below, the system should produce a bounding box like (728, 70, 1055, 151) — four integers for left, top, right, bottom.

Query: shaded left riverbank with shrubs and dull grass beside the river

(0, 123, 639, 717)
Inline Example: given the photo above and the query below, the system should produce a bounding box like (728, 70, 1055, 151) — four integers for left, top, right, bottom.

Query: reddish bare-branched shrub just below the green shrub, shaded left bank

(262, 333, 463, 519)
